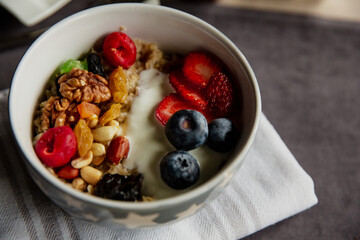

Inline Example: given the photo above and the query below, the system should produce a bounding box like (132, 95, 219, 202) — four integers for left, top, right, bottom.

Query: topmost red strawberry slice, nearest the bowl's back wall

(183, 52, 221, 88)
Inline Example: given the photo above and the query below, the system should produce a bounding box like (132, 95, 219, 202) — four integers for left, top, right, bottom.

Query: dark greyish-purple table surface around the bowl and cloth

(0, 1, 360, 240)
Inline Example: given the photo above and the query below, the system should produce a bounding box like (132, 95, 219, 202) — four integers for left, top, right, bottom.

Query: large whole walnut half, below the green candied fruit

(58, 68, 111, 103)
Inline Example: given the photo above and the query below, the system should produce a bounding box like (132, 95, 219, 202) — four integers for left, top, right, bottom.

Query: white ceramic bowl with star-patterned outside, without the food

(9, 3, 261, 228)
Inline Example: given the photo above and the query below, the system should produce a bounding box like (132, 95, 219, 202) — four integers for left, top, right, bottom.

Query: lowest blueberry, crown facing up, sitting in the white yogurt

(160, 150, 200, 189)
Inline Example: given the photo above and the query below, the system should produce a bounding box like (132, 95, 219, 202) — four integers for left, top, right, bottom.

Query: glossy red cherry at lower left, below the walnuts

(35, 126, 77, 167)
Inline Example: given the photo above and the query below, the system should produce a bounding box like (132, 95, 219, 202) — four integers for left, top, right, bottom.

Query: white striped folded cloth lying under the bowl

(0, 90, 317, 239)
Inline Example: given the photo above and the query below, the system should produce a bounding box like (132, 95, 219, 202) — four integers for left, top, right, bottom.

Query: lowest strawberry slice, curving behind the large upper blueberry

(155, 93, 215, 126)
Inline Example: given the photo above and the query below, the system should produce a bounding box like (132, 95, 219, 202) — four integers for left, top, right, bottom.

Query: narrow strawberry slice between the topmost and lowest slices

(169, 70, 207, 109)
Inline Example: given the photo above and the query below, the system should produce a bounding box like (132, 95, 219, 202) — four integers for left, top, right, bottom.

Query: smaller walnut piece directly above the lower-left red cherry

(40, 96, 79, 132)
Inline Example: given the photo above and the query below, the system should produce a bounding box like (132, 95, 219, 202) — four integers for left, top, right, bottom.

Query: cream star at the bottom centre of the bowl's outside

(114, 212, 159, 228)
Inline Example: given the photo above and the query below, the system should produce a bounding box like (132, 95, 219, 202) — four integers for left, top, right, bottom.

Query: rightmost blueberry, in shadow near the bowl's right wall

(206, 118, 239, 153)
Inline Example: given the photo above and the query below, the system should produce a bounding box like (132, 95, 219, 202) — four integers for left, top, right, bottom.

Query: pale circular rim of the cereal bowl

(8, 3, 261, 210)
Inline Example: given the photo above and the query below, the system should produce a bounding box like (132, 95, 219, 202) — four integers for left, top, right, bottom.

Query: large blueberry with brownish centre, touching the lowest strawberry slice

(165, 110, 209, 151)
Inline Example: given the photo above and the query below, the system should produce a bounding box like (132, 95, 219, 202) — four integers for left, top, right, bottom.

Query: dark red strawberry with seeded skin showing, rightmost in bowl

(206, 72, 234, 117)
